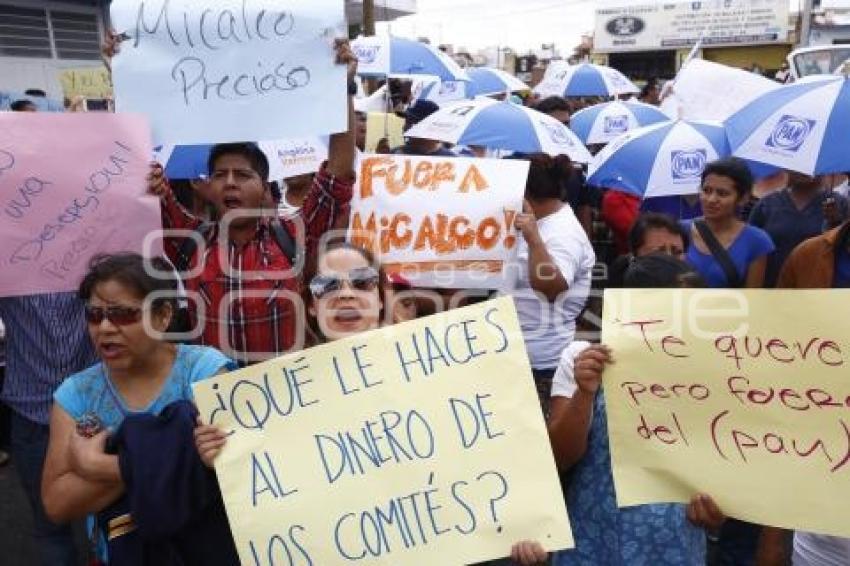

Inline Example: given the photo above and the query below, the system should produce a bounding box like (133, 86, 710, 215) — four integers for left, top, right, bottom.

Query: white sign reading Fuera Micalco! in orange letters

(350, 155, 528, 289)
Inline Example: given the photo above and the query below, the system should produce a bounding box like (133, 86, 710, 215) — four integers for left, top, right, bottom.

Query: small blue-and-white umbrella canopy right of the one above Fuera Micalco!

(570, 101, 668, 144)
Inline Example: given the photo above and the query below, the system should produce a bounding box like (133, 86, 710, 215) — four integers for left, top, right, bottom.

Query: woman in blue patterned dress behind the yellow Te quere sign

(514, 254, 723, 566)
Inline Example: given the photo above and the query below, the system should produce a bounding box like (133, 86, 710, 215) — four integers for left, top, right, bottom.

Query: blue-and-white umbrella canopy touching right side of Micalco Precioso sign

(351, 35, 469, 81)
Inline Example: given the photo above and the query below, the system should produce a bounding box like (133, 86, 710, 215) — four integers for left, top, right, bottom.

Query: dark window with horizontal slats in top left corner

(0, 4, 100, 60)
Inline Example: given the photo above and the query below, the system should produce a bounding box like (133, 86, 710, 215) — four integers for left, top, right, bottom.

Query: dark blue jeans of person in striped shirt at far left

(11, 411, 77, 566)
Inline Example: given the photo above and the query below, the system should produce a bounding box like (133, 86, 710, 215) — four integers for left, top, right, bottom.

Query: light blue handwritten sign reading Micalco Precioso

(112, 0, 347, 144)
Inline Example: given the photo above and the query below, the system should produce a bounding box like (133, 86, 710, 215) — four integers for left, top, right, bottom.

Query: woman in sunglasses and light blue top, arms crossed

(42, 254, 234, 523)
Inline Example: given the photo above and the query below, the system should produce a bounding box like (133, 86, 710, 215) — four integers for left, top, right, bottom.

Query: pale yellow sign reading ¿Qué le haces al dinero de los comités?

(194, 298, 572, 566)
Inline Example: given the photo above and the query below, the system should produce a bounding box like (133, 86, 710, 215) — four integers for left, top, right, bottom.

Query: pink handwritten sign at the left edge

(0, 112, 161, 296)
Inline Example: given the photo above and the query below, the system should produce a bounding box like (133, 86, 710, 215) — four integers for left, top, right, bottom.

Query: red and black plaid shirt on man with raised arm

(162, 167, 353, 363)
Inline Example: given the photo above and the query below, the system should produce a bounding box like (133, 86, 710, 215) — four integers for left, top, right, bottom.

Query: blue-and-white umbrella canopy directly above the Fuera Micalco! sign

(405, 98, 591, 163)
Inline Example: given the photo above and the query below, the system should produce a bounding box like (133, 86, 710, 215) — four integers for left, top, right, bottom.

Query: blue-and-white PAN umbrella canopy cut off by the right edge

(726, 76, 850, 175)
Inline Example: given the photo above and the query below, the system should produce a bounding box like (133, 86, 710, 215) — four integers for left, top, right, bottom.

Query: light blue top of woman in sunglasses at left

(53, 344, 237, 431)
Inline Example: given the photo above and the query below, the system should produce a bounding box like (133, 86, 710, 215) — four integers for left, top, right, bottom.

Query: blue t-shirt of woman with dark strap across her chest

(682, 221, 774, 289)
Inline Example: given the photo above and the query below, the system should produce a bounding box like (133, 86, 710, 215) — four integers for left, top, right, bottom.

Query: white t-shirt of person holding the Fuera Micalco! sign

(512, 205, 596, 369)
